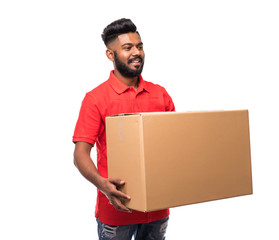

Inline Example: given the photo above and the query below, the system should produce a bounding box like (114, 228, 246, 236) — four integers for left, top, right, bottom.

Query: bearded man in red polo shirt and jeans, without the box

(73, 19, 175, 240)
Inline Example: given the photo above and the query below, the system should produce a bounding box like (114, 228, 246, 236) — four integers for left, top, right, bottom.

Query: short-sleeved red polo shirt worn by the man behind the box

(73, 71, 175, 225)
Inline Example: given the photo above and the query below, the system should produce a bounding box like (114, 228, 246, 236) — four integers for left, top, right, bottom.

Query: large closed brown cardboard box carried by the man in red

(106, 110, 252, 212)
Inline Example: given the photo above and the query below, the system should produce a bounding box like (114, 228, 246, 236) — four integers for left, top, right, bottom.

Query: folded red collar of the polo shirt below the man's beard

(108, 70, 149, 94)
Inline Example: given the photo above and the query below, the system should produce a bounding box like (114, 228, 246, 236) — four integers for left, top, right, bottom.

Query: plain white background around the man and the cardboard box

(0, 0, 279, 240)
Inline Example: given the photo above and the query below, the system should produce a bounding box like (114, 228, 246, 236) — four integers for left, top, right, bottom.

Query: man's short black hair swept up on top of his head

(102, 18, 139, 46)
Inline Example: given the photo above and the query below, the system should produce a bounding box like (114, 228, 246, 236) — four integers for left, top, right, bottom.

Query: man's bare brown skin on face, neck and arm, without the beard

(74, 33, 144, 212)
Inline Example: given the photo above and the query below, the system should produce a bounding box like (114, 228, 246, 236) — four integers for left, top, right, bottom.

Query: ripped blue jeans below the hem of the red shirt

(97, 217, 169, 240)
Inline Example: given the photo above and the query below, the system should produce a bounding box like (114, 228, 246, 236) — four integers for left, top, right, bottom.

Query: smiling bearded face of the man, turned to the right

(109, 33, 144, 77)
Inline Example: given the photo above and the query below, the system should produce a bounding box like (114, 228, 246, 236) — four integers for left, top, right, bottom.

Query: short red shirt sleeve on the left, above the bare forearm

(73, 93, 101, 145)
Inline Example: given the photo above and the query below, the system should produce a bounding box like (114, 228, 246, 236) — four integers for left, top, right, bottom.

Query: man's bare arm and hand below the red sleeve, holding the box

(74, 142, 131, 212)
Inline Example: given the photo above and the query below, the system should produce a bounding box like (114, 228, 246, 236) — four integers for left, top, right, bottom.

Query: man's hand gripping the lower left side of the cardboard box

(99, 178, 131, 212)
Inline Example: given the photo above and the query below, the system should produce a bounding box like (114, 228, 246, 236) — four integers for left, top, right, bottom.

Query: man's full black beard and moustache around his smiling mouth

(114, 51, 144, 78)
